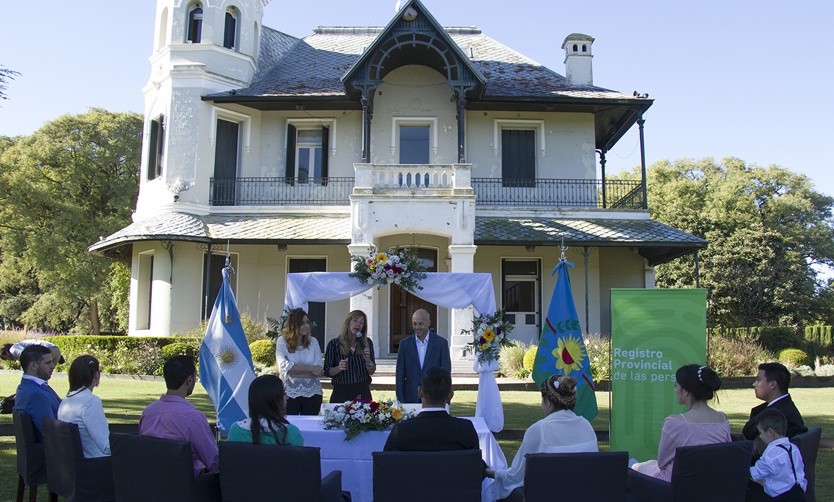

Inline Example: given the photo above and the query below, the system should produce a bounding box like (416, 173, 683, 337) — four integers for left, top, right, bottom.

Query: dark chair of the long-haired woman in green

(218, 442, 343, 502)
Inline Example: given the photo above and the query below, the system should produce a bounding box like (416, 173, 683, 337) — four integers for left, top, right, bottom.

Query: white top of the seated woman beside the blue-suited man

(58, 387, 110, 458)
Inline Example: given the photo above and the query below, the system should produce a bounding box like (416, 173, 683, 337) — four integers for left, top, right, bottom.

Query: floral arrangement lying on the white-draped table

(322, 398, 414, 441)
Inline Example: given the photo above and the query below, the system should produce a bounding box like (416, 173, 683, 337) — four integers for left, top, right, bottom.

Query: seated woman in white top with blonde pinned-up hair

(487, 375, 599, 499)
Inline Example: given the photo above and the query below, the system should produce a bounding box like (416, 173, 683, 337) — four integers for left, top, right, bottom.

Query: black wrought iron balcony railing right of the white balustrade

(472, 178, 643, 209)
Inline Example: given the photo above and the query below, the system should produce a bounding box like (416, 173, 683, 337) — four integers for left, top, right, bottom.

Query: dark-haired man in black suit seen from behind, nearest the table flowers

(383, 366, 480, 451)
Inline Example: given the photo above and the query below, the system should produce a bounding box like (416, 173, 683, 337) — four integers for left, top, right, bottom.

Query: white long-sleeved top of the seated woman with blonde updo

(493, 410, 599, 499)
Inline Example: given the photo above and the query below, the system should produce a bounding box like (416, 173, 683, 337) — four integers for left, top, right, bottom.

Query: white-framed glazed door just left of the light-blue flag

(502, 260, 541, 345)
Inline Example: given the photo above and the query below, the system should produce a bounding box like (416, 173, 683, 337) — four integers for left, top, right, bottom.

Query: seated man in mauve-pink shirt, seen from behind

(139, 356, 220, 476)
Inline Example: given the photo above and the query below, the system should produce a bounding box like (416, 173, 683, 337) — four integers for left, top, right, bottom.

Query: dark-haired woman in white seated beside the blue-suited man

(57, 356, 110, 458)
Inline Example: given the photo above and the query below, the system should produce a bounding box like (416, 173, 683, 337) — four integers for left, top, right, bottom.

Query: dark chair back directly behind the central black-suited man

(372, 450, 484, 502)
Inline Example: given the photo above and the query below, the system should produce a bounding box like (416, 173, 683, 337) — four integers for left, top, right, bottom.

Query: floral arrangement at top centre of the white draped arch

(350, 247, 426, 291)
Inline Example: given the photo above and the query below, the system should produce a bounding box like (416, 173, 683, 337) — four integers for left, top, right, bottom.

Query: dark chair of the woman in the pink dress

(626, 441, 753, 502)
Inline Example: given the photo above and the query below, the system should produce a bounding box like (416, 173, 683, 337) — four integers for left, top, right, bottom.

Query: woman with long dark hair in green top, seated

(228, 375, 304, 446)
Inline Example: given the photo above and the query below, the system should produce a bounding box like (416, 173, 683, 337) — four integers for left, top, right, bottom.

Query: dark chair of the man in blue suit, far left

(12, 410, 55, 502)
